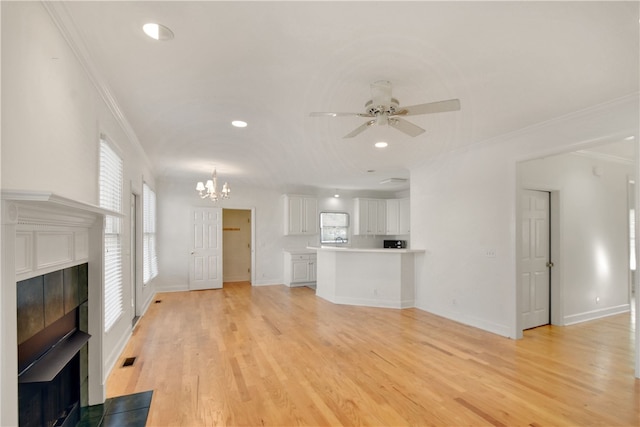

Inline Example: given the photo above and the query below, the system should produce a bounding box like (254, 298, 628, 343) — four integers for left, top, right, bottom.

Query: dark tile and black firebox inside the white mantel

(17, 263, 90, 427)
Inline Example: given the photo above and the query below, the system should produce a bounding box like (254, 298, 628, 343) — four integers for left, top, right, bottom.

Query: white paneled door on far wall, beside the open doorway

(189, 208, 222, 290)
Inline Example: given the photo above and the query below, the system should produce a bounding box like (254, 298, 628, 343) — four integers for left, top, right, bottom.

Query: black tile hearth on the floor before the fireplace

(78, 391, 153, 427)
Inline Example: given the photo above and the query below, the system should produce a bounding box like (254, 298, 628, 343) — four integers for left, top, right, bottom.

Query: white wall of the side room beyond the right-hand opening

(518, 154, 634, 324)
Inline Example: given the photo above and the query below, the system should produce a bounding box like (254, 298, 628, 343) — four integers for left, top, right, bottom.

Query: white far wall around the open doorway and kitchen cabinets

(156, 178, 406, 292)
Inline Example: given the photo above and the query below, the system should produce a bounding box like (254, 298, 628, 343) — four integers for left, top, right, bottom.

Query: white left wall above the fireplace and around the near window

(0, 2, 155, 425)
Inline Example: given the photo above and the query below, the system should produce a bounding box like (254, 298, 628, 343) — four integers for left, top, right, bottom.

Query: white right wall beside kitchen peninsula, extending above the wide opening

(411, 94, 638, 338)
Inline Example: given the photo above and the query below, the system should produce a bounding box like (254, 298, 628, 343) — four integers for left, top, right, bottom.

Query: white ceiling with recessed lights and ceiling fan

(60, 1, 639, 191)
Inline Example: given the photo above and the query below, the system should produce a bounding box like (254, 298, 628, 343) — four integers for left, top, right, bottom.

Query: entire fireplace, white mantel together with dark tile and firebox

(0, 190, 119, 425)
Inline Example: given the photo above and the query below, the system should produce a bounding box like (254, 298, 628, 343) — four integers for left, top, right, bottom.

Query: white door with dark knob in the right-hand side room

(520, 190, 551, 329)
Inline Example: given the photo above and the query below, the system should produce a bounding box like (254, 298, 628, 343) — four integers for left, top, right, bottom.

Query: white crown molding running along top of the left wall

(42, 1, 154, 171)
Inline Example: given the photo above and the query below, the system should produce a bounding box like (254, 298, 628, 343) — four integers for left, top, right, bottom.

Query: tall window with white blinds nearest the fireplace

(99, 138, 123, 332)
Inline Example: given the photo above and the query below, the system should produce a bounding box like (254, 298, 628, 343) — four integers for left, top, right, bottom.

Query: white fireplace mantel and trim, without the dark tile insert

(0, 190, 124, 425)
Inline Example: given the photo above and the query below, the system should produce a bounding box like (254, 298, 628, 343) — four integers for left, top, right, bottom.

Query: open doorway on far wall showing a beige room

(222, 209, 252, 283)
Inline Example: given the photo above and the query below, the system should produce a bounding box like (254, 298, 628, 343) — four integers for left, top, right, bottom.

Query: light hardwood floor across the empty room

(107, 283, 640, 426)
